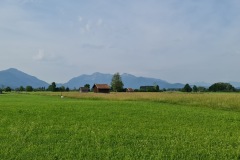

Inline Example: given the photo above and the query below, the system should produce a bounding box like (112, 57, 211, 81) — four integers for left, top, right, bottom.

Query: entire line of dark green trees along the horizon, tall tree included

(0, 72, 240, 93)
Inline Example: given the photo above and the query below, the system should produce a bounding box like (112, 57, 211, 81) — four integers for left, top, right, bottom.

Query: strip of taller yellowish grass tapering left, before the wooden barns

(38, 92, 240, 111)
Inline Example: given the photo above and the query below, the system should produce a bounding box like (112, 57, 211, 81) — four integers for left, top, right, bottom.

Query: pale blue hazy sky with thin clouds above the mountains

(0, 0, 240, 83)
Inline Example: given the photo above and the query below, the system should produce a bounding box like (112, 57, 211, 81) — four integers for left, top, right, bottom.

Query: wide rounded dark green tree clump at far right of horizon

(208, 82, 236, 92)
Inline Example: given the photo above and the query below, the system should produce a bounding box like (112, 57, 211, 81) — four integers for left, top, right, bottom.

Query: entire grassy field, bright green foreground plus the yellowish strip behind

(0, 93, 240, 160)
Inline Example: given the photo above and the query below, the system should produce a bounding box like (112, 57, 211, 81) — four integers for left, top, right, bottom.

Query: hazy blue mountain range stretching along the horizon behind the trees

(0, 68, 240, 89)
